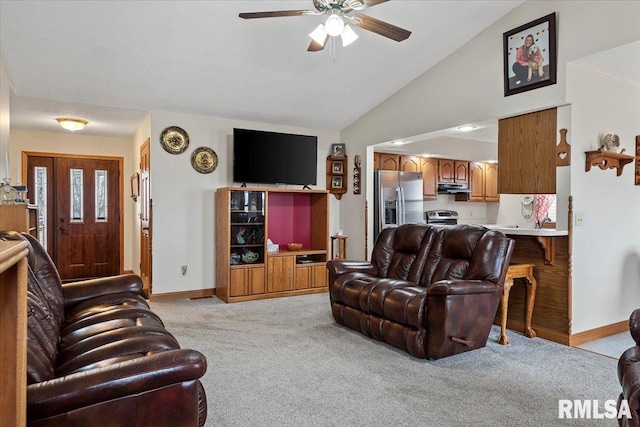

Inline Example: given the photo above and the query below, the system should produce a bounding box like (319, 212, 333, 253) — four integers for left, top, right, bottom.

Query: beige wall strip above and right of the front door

(10, 129, 135, 270)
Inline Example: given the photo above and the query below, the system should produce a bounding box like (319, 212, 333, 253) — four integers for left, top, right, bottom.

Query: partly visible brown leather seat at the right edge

(618, 309, 640, 427)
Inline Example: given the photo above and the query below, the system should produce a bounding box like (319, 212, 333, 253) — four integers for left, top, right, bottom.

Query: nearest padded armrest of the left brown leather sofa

(27, 350, 207, 420)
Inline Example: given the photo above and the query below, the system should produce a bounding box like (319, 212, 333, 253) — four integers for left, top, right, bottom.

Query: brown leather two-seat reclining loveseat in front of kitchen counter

(327, 224, 514, 359)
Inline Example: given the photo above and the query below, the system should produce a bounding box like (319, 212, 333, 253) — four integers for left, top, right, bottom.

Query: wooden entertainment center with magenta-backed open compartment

(216, 187, 329, 302)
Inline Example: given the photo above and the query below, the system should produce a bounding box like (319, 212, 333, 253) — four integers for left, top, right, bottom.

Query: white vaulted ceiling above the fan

(0, 0, 523, 138)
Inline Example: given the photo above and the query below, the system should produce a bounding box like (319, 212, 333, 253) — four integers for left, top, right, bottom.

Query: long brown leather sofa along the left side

(0, 231, 207, 427)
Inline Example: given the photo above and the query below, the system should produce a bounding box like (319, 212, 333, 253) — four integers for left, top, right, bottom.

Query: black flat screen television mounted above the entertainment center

(233, 129, 318, 185)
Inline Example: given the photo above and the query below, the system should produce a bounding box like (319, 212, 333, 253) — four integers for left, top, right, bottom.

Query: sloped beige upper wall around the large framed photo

(340, 1, 640, 258)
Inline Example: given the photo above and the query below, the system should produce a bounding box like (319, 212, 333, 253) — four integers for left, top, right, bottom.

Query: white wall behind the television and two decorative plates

(150, 112, 340, 295)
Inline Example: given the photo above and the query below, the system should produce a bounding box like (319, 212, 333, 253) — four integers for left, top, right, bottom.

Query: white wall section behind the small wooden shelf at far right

(567, 64, 640, 333)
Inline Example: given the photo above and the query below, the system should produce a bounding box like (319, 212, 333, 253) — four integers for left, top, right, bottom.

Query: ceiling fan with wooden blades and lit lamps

(239, 0, 411, 52)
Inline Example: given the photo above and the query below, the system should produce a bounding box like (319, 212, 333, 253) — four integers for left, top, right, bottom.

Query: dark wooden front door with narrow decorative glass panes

(27, 155, 121, 281)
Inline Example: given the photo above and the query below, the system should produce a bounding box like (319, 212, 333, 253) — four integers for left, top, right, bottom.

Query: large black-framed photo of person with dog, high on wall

(502, 12, 557, 96)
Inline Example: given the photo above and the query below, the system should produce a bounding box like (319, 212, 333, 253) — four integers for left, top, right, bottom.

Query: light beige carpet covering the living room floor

(151, 293, 620, 427)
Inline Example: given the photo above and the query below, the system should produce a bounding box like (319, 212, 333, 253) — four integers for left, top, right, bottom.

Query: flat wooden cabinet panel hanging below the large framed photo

(498, 108, 558, 194)
